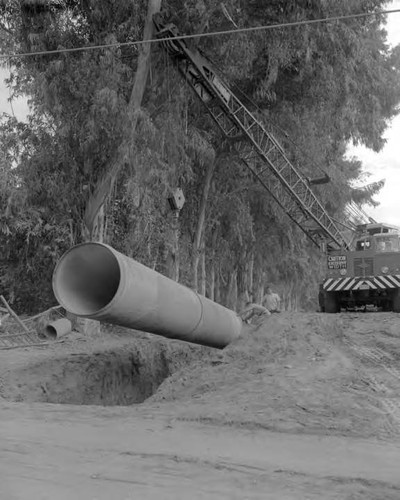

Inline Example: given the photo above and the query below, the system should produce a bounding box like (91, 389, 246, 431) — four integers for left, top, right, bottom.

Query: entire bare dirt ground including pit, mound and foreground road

(0, 313, 400, 500)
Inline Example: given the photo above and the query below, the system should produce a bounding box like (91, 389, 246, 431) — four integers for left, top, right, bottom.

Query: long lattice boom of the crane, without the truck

(154, 14, 350, 250)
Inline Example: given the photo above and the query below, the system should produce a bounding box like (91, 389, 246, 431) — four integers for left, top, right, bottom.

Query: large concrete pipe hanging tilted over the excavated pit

(53, 243, 242, 348)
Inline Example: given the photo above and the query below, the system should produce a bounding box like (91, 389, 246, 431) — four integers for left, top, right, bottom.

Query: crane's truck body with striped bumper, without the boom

(319, 223, 400, 313)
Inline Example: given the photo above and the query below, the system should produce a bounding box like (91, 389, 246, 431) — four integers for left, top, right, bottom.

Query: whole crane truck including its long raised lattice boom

(153, 14, 400, 313)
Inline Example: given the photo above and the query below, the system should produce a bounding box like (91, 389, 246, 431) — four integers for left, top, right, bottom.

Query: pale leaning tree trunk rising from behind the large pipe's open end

(84, 0, 162, 241)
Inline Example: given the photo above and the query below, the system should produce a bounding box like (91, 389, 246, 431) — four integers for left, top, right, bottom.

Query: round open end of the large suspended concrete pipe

(53, 243, 121, 316)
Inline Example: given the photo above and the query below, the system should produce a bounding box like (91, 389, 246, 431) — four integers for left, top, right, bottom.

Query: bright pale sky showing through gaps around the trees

(0, 0, 400, 226)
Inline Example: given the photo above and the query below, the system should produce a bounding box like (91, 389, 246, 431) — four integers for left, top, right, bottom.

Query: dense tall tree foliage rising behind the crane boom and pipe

(0, 0, 400, 310)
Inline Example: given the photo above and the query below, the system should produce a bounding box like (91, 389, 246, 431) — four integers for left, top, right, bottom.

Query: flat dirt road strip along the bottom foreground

(0, 404, 400, 500)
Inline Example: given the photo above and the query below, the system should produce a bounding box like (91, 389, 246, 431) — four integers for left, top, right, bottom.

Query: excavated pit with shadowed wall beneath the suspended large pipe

(0, 339, 214, 406)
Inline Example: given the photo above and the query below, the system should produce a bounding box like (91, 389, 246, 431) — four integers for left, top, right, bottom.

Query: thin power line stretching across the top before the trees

(0, 9, 400, 59)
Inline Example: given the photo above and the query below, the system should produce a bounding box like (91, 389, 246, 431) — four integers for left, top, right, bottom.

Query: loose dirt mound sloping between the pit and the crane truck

(148, 313, 384, 436)
